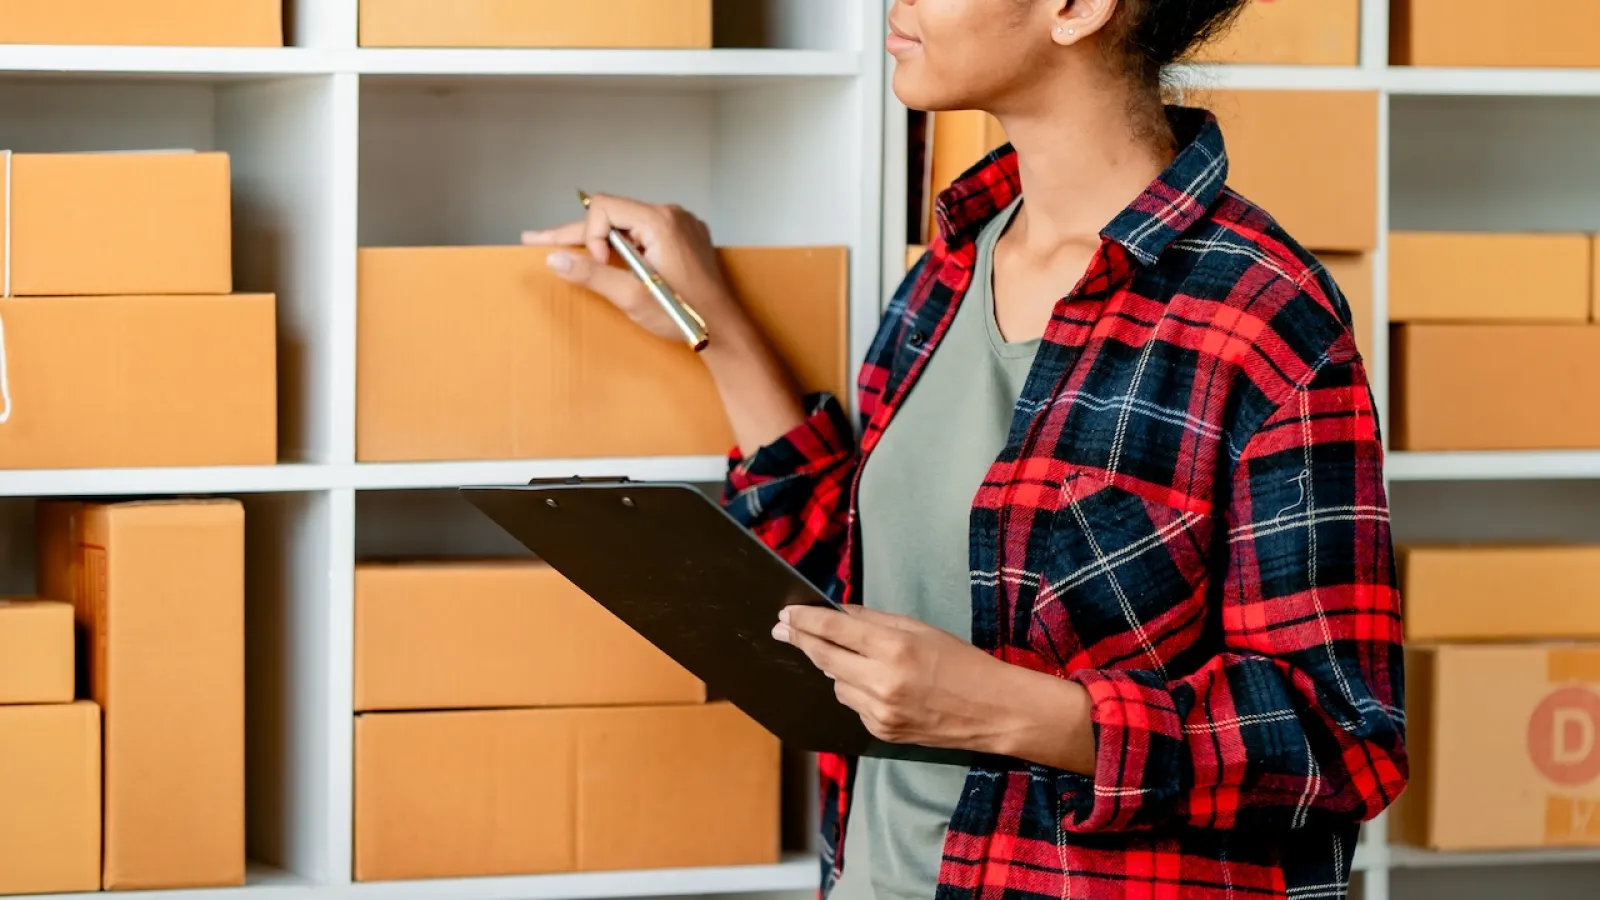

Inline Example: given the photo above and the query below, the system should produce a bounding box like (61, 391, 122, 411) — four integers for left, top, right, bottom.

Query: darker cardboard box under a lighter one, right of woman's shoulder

(1390, 325, 1600, 450)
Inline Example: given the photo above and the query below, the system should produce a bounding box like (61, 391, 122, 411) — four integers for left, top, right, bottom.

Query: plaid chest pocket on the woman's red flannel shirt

(1030, 469, 1218, 674)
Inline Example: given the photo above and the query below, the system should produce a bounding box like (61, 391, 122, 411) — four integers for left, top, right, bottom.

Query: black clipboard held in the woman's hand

(462, 479, 971, 764)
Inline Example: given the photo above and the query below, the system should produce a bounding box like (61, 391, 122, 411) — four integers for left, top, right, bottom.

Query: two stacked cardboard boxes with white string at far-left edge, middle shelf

(0, 150, 277, 469)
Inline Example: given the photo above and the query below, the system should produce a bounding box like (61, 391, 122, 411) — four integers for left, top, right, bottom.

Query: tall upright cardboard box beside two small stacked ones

(37, 500, 245, 889)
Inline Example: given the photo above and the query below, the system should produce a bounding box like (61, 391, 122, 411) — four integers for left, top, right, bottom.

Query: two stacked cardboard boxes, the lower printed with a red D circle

(1392, 546, 1600, 850)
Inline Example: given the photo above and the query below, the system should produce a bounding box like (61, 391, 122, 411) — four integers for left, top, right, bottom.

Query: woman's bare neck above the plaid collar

(995, 76, 1173, 258)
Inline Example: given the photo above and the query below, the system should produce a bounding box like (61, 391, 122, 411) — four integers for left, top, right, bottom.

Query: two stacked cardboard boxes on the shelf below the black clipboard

(355, 560, 779, 881)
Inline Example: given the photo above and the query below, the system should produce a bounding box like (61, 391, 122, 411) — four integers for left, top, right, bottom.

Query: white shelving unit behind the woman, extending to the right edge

(882, 0, 1600, 900)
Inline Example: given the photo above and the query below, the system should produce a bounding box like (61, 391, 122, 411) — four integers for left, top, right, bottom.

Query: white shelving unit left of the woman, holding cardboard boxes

(0, 0, 885, 900)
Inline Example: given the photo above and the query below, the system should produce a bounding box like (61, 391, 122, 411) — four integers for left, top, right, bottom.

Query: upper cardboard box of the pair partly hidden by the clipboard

(355, 562, 706, 711)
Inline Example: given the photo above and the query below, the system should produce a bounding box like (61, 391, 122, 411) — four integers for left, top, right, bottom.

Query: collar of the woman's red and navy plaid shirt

(936, 106, 1227, 266)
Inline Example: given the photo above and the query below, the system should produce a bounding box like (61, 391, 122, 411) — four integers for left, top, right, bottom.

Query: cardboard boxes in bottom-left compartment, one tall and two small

(0, 501, 245, 894)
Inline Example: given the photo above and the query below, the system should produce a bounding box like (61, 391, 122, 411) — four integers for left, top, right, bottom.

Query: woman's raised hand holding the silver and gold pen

(522, 194, 739, 341)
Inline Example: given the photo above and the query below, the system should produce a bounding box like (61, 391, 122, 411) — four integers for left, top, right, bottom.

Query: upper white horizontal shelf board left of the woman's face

(0, 45, 862, 83)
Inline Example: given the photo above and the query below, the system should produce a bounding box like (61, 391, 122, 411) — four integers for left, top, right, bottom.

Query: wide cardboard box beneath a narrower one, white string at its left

(0, 295, 277, 469)
